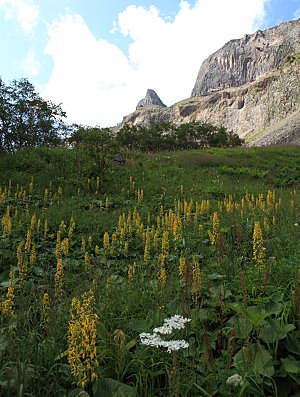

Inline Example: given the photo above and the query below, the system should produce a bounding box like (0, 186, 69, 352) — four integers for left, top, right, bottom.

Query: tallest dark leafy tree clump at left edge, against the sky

(0, 78, 68, 152)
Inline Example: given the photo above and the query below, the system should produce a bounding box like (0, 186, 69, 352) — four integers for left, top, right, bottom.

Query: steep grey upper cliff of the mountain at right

(192, 19, 300, 97)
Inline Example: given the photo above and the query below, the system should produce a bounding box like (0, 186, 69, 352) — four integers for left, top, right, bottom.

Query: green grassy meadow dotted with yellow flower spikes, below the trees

(0, 147, 300, 397)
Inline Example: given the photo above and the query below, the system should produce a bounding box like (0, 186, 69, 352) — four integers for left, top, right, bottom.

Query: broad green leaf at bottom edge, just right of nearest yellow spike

(93, 378, 135, 397)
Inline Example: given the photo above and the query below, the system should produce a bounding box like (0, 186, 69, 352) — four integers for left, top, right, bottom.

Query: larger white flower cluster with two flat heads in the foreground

(139, 314, 191, 353)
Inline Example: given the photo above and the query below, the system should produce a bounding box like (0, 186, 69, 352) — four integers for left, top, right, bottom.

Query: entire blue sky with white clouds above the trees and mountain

(0, 0, 300, 127)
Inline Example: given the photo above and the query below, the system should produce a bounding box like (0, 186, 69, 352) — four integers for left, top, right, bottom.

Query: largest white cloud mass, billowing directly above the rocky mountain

(45, 0, 268, 126)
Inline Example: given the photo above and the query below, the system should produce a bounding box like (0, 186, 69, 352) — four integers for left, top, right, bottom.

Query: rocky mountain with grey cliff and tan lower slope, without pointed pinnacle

(121, 19, 300, 145)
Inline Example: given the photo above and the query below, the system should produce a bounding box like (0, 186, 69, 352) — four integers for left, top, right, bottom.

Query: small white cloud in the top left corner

(0, 0, 39, 34)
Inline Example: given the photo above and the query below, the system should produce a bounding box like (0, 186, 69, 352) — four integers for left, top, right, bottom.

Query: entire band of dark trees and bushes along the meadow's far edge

(0, 78, 243, 154)
